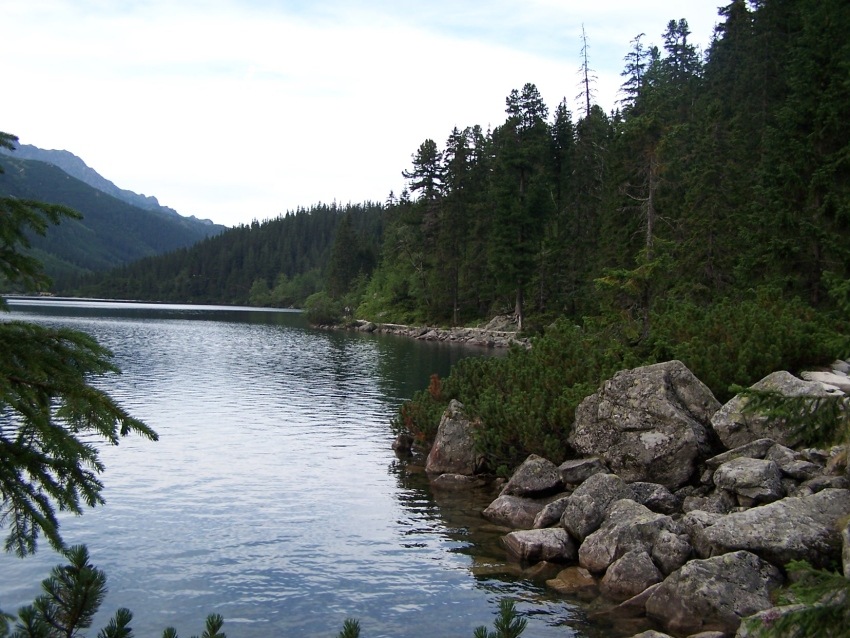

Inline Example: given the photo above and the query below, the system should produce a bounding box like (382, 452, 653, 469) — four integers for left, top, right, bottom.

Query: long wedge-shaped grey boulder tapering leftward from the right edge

(697, 489, 850, 568)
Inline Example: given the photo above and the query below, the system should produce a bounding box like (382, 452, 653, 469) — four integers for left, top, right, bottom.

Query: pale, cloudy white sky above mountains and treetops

(0, 0, 726, 226)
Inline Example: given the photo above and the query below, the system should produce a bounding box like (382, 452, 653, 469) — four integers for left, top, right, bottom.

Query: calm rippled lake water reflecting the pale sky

(0, 301, 608, 638)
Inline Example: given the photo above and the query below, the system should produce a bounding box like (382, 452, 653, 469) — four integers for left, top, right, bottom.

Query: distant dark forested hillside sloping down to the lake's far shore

(73, 203, 384, 307)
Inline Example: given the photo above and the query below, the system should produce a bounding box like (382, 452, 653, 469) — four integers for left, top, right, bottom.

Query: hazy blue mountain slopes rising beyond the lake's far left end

(0, 153, 224, 284)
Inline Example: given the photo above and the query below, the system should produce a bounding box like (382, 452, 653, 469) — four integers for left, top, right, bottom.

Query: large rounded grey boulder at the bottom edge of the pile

(646, 551, 782, 635)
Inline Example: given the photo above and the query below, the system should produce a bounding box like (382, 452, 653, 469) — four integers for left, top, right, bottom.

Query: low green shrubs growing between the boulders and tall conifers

(395, 289, 848, 474)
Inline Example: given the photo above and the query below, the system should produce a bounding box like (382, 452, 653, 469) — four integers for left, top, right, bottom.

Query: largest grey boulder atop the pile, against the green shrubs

(570, 361, 720, 490)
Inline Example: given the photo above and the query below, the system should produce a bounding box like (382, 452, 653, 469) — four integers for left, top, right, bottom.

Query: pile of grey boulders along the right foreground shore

(408, 361, 850, 638)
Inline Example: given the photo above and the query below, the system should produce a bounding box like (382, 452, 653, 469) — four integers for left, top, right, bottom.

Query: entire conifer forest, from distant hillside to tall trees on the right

(77, 0, 850, 340)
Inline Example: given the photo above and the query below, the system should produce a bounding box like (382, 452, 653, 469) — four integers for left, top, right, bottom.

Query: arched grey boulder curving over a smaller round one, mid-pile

(578, 499, 691, 573)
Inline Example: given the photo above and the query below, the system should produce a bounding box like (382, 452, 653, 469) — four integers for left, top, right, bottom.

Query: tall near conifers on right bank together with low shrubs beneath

(396, 0, 850, 473)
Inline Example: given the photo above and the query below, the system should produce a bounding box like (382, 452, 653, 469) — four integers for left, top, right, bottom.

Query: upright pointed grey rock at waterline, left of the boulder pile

(425, 399, 482, 476)
